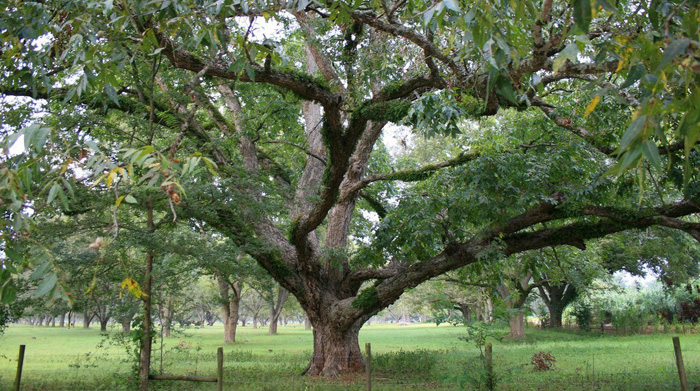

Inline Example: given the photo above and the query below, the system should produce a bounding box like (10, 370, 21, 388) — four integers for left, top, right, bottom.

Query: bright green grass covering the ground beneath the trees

(0, 324, 700, 391)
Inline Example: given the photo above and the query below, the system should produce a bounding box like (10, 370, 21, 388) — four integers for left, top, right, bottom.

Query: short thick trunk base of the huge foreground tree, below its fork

(304, 322, 365, 377)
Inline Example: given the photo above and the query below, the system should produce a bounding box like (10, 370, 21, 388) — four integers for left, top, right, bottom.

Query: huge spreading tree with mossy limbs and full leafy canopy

(0, 0, 700, 391)
